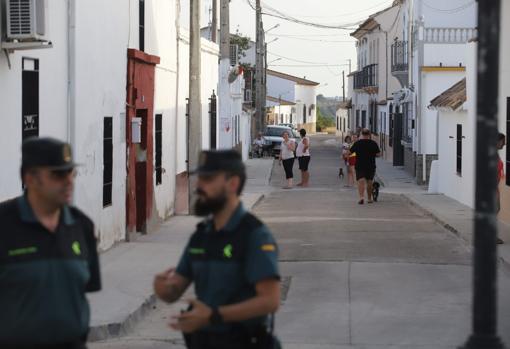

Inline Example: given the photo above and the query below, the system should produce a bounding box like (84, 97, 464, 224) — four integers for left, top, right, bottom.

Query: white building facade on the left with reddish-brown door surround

(0, 0, 218, 250)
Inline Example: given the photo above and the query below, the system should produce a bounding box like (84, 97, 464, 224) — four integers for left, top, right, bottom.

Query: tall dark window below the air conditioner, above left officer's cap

(21, 58, 39, 139)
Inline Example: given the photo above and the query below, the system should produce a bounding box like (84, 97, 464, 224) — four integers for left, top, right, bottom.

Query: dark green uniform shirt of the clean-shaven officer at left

(0, 196, 101, 348)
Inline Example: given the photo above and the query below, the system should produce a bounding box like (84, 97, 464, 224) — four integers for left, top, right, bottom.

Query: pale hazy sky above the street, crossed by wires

(203, 0, 393, 97)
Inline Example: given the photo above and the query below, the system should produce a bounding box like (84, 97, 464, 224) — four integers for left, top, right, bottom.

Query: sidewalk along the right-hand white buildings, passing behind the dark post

(377, 159, 510, 270)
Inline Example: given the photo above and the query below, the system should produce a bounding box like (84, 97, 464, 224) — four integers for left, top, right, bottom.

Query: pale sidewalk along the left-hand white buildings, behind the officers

(88, 159, 273, 341)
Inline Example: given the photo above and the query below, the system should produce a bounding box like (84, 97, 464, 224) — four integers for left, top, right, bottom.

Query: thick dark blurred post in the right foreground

(462, 0, 505, 349)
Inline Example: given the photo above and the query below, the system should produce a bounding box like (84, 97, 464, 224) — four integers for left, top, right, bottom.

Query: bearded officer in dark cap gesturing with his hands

(154, 150, 280, 349)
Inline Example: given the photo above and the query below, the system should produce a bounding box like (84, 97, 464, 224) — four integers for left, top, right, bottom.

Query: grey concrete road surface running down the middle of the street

(91, 136, 510, 349)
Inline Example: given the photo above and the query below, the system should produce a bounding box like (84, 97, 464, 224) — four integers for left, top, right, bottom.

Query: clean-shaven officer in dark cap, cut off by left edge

(0, 138, 101, 349)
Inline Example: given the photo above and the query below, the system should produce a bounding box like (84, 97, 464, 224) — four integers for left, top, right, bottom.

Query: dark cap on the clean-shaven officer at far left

(21, 137, 76, 171)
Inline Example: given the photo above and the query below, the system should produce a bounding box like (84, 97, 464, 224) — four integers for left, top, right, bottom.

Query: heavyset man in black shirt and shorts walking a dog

(350, 128, 381, 205)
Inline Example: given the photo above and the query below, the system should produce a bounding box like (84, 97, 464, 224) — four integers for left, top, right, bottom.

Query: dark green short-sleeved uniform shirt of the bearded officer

(177, 204, 280, 331)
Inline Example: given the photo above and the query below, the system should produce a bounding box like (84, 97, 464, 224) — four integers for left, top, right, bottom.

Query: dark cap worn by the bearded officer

(192, 150, 246, 176)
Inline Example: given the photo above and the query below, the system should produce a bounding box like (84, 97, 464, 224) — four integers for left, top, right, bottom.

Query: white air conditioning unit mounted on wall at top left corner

(6, 0, 46, 41)
